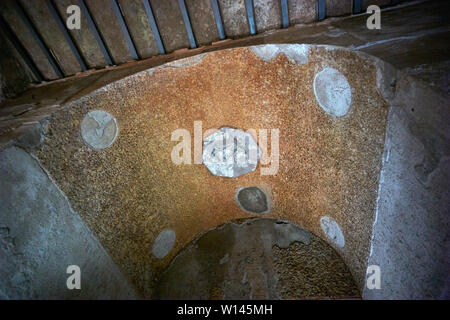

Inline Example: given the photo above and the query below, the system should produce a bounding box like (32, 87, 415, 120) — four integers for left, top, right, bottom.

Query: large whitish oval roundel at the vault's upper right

(314, 68, 352, 117)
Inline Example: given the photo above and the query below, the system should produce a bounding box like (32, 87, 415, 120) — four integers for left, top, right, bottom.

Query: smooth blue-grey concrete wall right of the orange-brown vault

(363, 75, 450, 299)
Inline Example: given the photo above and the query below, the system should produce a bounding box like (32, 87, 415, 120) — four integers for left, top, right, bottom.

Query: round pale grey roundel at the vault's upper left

(81, 110, 119, 150)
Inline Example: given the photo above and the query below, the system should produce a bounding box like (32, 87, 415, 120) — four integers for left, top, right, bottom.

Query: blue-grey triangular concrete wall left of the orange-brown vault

(0, 147, 137, 299)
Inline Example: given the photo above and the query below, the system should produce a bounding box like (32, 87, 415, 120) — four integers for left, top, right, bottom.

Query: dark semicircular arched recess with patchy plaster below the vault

(154, 219, 359, 299)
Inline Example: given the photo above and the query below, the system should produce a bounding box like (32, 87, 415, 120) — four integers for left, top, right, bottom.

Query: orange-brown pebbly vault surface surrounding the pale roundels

(28, 45, 388, 296)
